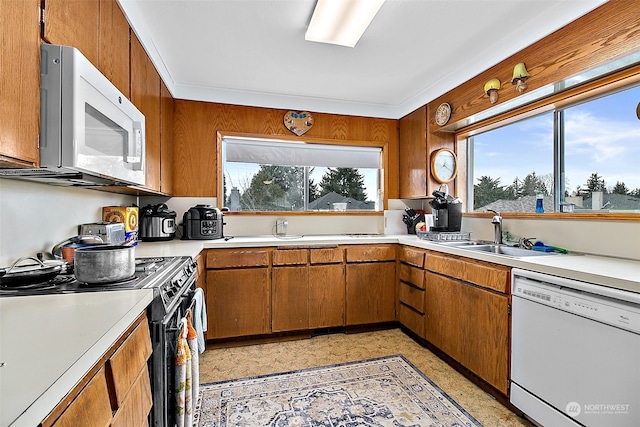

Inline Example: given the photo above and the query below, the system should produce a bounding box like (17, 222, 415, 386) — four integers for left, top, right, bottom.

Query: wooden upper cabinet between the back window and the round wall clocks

(398, 105, 428, 199)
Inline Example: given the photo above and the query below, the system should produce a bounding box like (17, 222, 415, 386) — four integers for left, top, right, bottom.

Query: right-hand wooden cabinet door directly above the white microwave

(98, 0, 131, 98)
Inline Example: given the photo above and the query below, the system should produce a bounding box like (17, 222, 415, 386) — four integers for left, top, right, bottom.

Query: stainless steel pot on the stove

(74, 245, 136, 283)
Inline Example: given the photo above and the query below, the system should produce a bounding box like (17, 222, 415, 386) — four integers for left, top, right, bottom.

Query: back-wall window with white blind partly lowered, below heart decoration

(222, 136, 382, 212)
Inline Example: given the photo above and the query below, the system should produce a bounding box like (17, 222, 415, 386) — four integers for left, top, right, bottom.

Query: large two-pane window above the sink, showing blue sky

(466, 86, 640, 213)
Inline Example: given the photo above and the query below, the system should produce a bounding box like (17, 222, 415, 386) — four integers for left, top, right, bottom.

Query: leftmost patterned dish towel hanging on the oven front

(175, 317, 193, 427)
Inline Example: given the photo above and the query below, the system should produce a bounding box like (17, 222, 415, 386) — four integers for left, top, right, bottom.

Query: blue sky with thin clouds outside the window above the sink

(474, 86, 640, 192)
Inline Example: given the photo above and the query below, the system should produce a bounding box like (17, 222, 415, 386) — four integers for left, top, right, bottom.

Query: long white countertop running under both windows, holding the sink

(136, 234, 640, 293)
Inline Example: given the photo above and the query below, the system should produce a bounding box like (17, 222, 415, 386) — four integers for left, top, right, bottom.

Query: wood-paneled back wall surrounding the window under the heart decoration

(174, 100, 398, 198)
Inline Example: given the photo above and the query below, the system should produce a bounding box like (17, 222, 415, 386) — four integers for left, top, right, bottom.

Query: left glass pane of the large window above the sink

(467, 113, 553, 212)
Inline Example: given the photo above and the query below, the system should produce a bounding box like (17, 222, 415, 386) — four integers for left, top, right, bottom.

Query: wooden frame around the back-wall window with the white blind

(216, 131, 389, 216)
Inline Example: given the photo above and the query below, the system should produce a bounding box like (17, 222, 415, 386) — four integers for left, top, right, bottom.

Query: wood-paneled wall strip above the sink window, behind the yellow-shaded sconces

(428, 0, 640, 192)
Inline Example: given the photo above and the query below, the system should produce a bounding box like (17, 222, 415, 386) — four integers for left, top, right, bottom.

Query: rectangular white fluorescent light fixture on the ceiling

(304, 0, 384, 47)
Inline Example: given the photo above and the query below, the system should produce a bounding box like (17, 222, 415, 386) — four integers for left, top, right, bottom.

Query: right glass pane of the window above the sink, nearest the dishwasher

(559, 86, 640, 212)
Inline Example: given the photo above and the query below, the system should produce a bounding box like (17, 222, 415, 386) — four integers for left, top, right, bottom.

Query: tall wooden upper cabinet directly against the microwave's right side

(131, 34, 160, 191)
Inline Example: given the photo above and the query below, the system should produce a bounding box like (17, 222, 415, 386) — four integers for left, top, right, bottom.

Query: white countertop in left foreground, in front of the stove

(0, 289, 153, 427)
